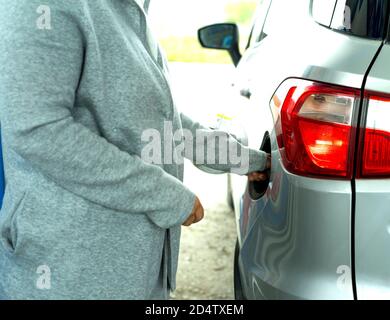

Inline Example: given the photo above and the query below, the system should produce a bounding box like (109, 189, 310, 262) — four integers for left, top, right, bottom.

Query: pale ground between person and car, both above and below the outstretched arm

(171, 63, 236, 300)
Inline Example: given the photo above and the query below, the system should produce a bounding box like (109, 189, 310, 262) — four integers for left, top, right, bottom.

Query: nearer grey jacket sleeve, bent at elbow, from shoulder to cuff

(0, 0, 195, 228)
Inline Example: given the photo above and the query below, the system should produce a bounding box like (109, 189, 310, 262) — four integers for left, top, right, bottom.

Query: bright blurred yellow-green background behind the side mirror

(150, 0, 258, 63)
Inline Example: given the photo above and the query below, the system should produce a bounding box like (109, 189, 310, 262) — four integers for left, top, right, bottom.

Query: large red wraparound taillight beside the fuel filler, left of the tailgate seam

(271, 79, 360, 179)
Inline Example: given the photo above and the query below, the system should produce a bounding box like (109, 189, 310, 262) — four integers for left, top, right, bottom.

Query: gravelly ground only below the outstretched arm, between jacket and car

(172, 164, 236, 300)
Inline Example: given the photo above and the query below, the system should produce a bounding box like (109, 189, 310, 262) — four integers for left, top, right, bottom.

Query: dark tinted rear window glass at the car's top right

(331, 0, 388, 39)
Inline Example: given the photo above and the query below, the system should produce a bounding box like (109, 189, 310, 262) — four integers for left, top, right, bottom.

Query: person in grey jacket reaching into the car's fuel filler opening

(0, 0, 269, 299)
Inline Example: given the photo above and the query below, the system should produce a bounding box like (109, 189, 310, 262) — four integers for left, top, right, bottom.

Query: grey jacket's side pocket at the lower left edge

(0, 192, 26, 254)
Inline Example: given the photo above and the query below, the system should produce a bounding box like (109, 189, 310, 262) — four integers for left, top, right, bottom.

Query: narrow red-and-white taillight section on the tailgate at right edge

(361, 94, 390, 178)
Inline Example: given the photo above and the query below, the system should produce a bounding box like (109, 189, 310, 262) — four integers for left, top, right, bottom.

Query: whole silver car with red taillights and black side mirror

(199, 0, 390, 300)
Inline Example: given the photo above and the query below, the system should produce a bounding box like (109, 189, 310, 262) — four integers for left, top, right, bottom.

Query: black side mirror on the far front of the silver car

(198, 23, 241, 66)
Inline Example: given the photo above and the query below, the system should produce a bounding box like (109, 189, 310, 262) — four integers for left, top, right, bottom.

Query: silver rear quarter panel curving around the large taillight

(236, 0, 380, 299)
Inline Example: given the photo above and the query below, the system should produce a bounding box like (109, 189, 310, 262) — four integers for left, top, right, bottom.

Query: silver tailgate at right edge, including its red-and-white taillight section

(355, 42, 390, 300)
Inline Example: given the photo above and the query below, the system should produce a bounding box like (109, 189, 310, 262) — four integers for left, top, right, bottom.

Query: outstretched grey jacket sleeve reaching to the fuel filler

(180, 113, 267, 175)
